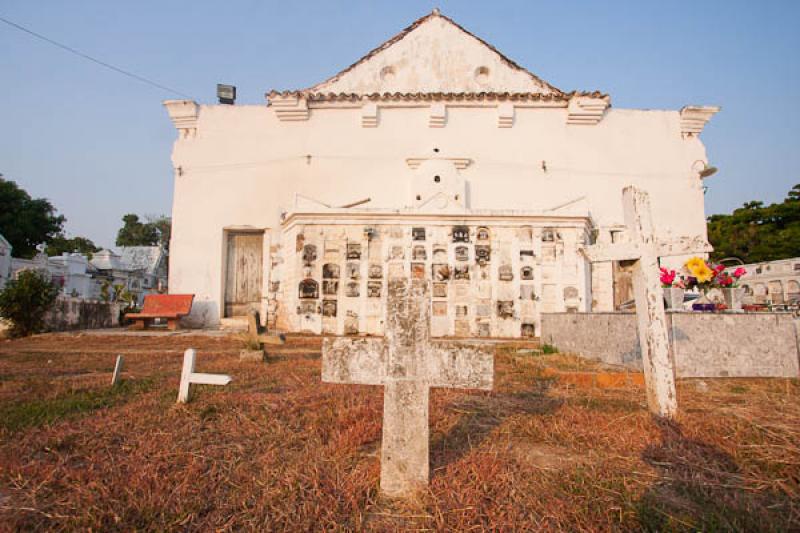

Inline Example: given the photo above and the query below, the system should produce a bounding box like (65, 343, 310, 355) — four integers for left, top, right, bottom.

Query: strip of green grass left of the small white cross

(0, 379, 153, 433)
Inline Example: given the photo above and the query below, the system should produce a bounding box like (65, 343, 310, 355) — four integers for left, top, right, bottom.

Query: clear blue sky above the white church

(0, 0, 800, 246)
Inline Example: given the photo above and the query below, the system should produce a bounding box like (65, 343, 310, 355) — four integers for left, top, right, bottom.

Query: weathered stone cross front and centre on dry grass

(322, 278, 494, 497)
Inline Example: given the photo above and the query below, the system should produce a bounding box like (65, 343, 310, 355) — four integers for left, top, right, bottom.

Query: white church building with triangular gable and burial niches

(164, 11, 719, 337)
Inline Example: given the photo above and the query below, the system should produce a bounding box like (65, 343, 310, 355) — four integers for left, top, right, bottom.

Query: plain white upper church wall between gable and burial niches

(170, 103, 705, 324)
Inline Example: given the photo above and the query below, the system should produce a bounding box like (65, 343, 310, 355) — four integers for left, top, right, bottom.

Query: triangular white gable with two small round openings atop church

(304, 10, 564, 95)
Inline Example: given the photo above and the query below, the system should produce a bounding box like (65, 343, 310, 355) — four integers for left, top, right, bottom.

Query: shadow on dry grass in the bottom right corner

(634, 420, 797, 531)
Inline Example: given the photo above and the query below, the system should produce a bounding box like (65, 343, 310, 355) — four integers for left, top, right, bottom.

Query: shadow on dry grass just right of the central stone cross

(430, 379, 564, 472)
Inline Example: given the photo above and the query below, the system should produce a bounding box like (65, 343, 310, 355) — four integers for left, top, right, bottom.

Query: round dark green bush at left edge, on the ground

(0, 270, 58, 337)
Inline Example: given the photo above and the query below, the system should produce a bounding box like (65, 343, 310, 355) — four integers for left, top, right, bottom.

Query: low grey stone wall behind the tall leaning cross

(541, 312, 800, 378)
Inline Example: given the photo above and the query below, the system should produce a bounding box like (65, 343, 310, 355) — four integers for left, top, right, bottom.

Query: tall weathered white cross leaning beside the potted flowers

(582, 186, 712, 418)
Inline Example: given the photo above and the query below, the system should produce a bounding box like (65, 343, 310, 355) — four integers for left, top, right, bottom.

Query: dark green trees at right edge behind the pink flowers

(708, 184, 800, 263)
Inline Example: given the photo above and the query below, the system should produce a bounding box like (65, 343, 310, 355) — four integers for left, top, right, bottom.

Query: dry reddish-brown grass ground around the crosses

(0, 334, 800, 531)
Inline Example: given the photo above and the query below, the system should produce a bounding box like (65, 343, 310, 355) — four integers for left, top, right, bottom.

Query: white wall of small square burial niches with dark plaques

(270, 214, 590, 337)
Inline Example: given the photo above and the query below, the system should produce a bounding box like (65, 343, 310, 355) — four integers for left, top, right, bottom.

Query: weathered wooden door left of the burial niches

(225, 232, 264, 316)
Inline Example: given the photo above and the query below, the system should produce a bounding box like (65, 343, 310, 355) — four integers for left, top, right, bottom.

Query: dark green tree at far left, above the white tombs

(0, 177, 66, 258)
